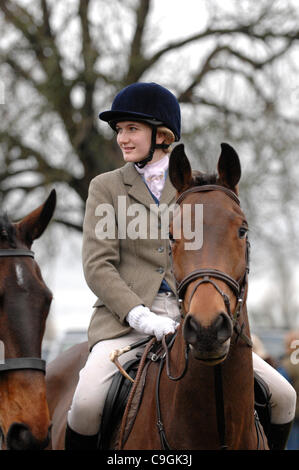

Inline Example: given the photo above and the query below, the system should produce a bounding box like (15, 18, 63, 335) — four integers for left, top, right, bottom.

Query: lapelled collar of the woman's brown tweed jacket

(122, 162, 176, 207)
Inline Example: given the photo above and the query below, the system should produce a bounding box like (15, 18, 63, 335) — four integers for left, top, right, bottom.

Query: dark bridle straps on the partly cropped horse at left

(0, 248, 46, 373)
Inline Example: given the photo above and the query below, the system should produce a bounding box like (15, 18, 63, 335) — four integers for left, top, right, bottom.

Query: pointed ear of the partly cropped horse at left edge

(16, 189, 56, 248)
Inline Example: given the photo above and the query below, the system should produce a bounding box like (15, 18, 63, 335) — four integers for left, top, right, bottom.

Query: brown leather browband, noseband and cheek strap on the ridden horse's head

(176, 184, 252, 347)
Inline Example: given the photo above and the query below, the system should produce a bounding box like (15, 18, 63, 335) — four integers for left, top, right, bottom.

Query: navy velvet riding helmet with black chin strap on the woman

(99, 82, 181, 168)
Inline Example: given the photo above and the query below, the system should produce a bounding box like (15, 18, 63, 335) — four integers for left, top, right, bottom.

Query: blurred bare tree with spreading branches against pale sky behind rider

(0, 0, 299, 326)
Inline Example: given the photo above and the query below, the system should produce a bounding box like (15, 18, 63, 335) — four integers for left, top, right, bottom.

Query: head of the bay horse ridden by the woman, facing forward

(169, 144, 248, 365)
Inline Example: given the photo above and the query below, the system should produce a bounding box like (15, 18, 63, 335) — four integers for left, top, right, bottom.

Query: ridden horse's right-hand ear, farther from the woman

(217, 143, 241, 194)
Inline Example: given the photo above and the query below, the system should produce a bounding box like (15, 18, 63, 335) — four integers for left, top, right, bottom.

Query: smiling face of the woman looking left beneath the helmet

(116, 121, 164, 163)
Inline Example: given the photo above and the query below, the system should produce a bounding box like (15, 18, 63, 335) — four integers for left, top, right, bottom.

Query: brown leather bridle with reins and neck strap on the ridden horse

(156, 184, 259, 450)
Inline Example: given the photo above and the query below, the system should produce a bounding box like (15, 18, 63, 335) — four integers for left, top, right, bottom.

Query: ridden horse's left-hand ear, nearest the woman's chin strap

(168, 144, 192, 193)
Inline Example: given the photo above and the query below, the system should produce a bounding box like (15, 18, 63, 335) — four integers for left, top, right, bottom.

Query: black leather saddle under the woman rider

(98, 343, 271, 450)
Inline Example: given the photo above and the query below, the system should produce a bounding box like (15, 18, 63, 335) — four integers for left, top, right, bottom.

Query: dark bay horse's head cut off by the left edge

(0, 190, 56, 450)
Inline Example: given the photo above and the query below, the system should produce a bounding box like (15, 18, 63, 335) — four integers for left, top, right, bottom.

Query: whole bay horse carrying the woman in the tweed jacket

(47, 144, 267, 450)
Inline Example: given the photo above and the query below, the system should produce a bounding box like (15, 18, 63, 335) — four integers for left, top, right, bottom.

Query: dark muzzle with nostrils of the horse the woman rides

(183, 312, 233, 365)
